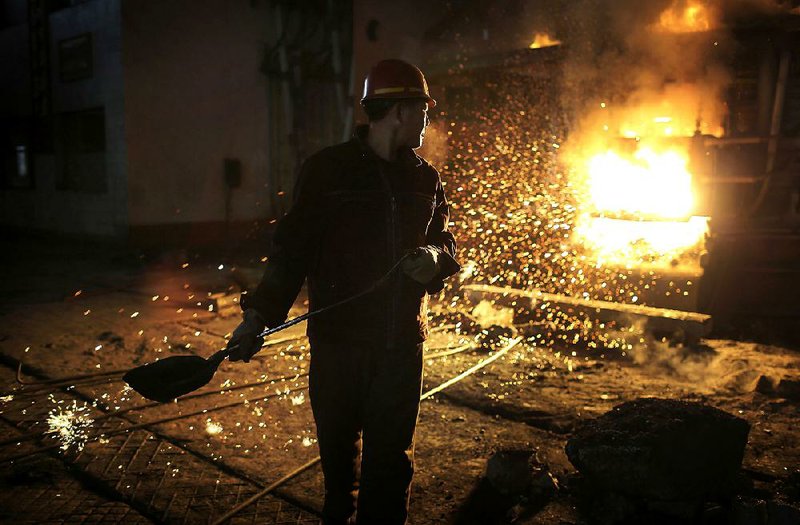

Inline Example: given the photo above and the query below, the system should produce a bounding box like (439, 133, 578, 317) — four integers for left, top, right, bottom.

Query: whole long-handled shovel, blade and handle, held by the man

(122, 252, 414, 403)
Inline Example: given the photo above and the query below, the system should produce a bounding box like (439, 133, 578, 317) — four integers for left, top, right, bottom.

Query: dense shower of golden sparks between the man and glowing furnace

(432, 62, 705, 350)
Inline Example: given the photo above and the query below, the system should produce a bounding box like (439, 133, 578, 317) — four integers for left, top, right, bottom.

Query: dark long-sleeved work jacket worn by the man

(242, 126, 459, 346)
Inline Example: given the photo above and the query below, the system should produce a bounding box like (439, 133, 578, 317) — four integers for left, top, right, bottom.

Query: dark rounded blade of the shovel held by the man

(122, 355, 216, 403)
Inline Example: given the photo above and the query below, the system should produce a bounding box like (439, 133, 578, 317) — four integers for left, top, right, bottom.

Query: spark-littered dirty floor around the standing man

(0, 234, 800, 524)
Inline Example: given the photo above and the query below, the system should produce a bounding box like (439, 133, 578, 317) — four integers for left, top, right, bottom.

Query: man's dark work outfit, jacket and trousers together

(242, 126, 459, 525)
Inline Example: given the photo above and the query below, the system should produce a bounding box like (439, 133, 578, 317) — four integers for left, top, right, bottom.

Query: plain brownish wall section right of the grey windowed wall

(122, 0, 270, 233)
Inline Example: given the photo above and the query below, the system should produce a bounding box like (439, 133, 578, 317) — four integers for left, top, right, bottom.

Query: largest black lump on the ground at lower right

(566, 399, 750, 523)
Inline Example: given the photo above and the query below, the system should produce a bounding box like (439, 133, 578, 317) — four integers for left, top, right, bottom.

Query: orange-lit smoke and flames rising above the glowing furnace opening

(556, 0, 797, 146)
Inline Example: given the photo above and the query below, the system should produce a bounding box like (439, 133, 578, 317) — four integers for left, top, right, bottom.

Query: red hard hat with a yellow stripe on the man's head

(361, 58, 436, 108)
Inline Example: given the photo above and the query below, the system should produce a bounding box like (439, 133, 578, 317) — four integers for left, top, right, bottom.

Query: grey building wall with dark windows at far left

(0, 0, 127, 236)
